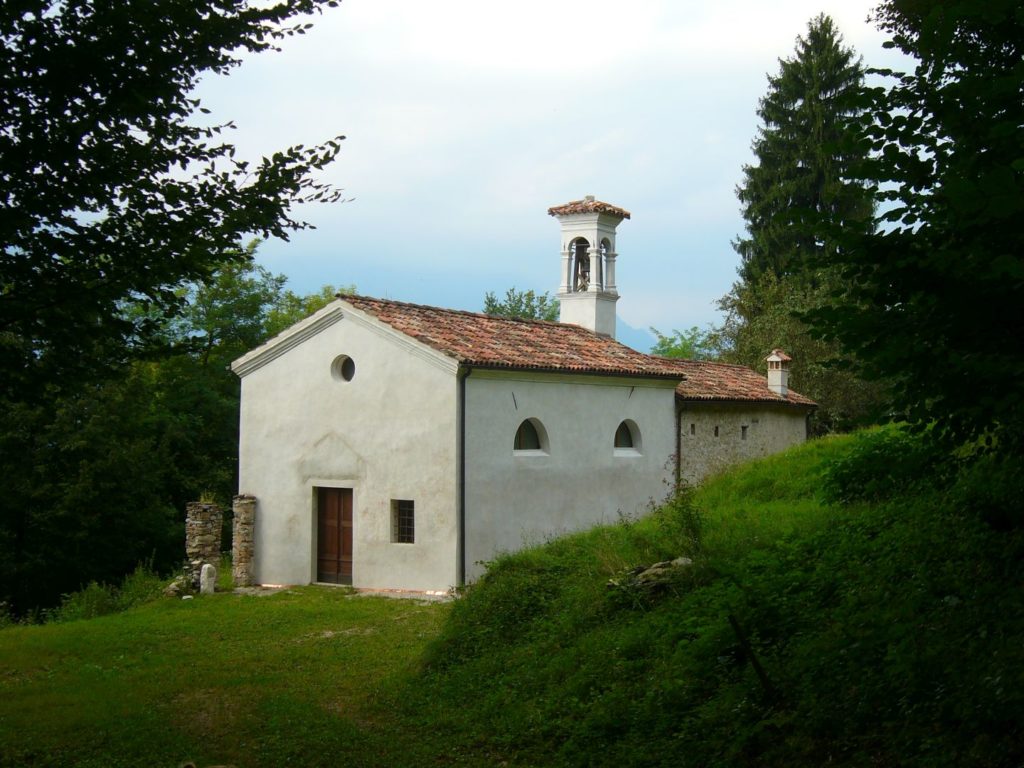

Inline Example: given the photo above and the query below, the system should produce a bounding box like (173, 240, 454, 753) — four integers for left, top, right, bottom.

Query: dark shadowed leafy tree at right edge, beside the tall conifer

(811, 0, 1024, 451)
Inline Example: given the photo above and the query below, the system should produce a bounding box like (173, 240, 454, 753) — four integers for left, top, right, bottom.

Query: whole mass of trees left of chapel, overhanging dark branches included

(0, 0, 352, 615)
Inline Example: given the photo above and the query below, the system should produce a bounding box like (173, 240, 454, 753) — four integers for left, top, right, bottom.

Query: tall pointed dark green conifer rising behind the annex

(733, 15, 873, 286)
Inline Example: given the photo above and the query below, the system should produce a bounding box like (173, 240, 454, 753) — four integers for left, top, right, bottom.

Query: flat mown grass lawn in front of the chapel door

(0, 587, 449, 768)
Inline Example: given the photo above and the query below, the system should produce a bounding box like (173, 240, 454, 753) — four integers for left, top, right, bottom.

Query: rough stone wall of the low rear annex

(679, 401, 807, 485)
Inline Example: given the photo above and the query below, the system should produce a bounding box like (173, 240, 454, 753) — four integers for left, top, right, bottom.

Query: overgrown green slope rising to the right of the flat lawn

(401, 436, 1024, 768)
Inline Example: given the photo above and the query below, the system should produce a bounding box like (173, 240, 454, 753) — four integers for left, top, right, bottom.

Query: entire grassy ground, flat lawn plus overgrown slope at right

(0, 430, 1024, 767)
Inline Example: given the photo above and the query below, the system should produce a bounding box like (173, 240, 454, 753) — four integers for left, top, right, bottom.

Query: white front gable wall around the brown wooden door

(237, 309, 457, 590)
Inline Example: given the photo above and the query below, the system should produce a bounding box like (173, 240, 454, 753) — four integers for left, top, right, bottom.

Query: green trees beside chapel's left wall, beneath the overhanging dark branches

(0, 249, 350, 614)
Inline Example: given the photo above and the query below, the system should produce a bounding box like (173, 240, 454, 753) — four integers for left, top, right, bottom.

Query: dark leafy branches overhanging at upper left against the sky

(0, 0, 342, 401)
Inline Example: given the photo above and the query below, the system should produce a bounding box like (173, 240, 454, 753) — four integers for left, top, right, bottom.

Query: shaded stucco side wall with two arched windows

(465, 370, 676, 579)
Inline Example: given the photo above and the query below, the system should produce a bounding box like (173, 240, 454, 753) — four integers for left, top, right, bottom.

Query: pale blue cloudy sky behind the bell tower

(197, 0, 895, 351)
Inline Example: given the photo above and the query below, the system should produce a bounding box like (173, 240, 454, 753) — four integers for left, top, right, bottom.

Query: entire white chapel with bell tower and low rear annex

(231, 197, 814, 591)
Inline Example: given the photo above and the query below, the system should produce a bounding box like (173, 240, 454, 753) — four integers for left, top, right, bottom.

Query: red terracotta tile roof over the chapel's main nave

(340, 296, 684, 379)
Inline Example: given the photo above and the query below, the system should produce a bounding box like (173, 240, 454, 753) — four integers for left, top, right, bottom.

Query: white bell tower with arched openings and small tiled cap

(548, 195, 630, 338)
